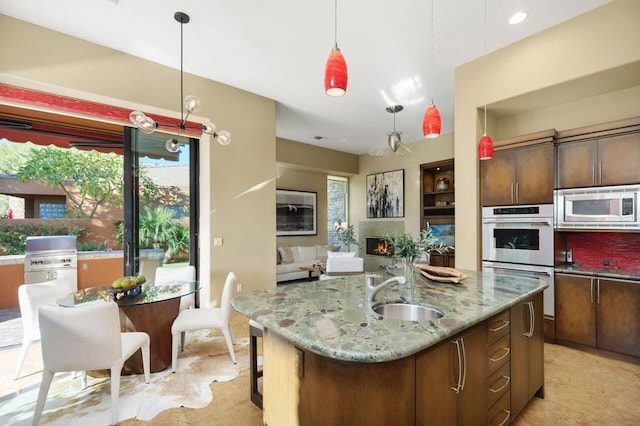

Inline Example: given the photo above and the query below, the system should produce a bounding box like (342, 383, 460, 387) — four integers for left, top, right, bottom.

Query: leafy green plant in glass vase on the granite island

(384, 228, 452, 285)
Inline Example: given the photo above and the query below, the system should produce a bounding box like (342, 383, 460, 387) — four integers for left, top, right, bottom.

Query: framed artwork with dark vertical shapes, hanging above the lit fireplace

(367, 169, 404, 218)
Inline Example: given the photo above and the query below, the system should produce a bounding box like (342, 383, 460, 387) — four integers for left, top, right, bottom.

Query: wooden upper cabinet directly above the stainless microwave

(556, 119, 640, 188)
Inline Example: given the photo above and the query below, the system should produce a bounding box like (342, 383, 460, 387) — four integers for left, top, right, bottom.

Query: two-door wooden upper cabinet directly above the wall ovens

(480, 130, 556, 206)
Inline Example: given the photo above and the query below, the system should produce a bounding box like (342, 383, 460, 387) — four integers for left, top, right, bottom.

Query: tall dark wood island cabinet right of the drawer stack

(511, 293, 544, 418)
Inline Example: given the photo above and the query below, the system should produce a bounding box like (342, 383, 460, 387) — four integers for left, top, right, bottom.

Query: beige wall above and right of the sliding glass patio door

(0, 15, 276, 303)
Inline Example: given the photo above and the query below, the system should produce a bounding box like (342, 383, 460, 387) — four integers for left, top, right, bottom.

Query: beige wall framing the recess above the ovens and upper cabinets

(455, 0, 640, 269)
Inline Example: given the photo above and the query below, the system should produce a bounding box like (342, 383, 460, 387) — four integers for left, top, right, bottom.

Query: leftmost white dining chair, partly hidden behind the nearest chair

(14, 279, 77, 380)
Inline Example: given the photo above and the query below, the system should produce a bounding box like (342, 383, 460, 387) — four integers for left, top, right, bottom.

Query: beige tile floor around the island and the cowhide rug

(0, 312, 640, 426)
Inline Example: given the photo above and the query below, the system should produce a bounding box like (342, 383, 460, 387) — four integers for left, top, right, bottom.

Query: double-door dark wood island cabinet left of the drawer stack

(416, 323, 488, 425)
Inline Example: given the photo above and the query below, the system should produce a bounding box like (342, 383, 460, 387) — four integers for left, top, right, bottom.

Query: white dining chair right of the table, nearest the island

(171, 272, 236, 373)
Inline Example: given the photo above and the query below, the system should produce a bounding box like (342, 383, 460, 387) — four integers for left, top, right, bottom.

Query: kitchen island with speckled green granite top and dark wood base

(233, 271, 547, 424)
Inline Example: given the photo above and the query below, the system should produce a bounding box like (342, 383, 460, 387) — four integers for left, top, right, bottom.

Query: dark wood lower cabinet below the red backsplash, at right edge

(555, 274, 640, 357)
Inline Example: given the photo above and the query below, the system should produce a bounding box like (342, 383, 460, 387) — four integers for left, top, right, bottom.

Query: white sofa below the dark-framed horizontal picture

(276, 245, 339, 282)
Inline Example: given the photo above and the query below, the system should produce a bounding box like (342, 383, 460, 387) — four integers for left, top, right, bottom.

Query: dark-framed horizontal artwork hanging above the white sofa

(276, 189, 318, 236)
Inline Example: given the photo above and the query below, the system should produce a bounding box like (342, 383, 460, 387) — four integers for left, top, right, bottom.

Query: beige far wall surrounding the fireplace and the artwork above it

(349, 133, 458, 238)
